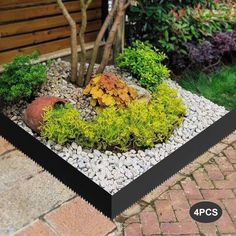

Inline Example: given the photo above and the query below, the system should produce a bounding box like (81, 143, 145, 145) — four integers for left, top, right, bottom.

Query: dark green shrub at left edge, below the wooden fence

(0, 53, 46, 103)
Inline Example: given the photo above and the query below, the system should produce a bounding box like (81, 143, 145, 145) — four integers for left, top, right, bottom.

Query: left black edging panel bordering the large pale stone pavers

(0, 113, 111, 217)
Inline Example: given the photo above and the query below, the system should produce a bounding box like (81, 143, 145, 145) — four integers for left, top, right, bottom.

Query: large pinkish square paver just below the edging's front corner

(44, 197, 115, 236)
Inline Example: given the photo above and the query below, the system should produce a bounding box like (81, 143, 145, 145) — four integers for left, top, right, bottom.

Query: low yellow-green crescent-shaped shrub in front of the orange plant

(41, 83, 185, 151)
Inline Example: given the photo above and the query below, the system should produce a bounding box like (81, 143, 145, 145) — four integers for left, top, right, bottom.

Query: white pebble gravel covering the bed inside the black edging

(2, 60, 228, 194)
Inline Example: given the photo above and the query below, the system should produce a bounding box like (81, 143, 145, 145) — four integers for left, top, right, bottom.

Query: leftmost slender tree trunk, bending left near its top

(57, 0, 78, 83)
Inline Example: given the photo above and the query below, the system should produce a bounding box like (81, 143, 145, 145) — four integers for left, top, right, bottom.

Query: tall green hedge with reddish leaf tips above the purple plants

(126, 0, 236, 52)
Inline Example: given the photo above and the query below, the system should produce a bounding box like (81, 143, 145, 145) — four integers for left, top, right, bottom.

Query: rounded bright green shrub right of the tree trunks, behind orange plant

(117, 41, 170, 91)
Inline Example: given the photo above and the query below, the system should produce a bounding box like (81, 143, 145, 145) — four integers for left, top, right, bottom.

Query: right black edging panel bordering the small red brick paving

(112, 109, 236, 217)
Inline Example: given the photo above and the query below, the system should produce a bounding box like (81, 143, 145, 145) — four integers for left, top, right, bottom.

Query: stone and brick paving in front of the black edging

(0, 132, 236, 236)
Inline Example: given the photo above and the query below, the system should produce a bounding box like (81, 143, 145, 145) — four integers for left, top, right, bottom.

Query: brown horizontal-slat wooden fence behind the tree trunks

(0, 0, 107, 64)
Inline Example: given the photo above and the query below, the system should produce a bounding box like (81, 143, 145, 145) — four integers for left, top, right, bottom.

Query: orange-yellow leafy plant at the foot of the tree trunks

(84, 73, 137, 107)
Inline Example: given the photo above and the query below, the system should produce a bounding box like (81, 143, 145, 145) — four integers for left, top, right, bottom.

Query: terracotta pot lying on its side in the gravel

(23, 96, 67, 133)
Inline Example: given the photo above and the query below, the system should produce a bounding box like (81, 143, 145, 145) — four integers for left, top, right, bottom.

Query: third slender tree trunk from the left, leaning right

(85, 0, 118, 85)
